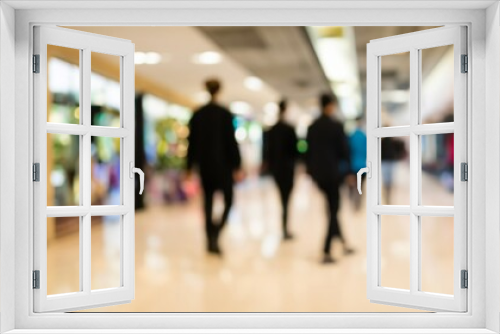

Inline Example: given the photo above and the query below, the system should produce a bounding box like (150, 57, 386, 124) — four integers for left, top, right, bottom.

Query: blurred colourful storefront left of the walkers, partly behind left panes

(47, 51, 198, 242)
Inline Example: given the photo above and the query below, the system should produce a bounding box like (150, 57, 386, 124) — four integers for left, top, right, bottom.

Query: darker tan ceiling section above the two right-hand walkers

(199, 26, 331, 107)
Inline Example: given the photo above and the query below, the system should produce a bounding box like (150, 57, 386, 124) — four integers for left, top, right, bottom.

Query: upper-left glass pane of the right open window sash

(380, 52, 410, 127)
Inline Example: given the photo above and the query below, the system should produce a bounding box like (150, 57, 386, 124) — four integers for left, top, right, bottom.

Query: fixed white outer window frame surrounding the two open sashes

(0, 0, 500, 333)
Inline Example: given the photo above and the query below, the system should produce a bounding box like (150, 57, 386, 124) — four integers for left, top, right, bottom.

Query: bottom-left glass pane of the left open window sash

(47, 217, 81, 295)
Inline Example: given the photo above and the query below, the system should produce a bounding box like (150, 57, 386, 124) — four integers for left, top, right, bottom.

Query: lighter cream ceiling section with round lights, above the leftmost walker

(71, 27, 280, 116)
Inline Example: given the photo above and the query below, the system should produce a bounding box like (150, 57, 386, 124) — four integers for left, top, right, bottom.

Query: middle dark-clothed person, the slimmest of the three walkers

(264, 100, 297, 240)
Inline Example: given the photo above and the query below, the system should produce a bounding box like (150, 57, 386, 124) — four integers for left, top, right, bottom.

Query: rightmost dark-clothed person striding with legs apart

(306, 94, 354, 263)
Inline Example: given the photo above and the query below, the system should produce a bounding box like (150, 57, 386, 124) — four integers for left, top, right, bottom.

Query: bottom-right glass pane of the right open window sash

(420, 217, 453, 295)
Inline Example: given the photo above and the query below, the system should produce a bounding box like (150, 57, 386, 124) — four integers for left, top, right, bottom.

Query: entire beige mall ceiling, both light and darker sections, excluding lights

(66, 26, 454, 123)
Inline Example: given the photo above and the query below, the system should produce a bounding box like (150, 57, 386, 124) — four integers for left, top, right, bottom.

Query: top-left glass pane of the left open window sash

(47, 45, 80, 124)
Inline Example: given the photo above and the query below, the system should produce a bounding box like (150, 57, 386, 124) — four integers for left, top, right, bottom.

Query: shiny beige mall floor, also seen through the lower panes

(48, 164, 453, 312)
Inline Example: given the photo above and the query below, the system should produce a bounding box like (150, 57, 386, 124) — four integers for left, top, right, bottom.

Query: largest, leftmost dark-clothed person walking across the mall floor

(187, 79, 242, 255)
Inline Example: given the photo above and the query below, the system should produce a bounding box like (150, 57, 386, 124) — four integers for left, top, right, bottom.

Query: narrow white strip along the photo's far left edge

(0, 3, 15, 333)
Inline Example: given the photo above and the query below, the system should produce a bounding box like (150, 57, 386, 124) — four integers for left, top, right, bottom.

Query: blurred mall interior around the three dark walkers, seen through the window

(47, 26, 453, 312)
